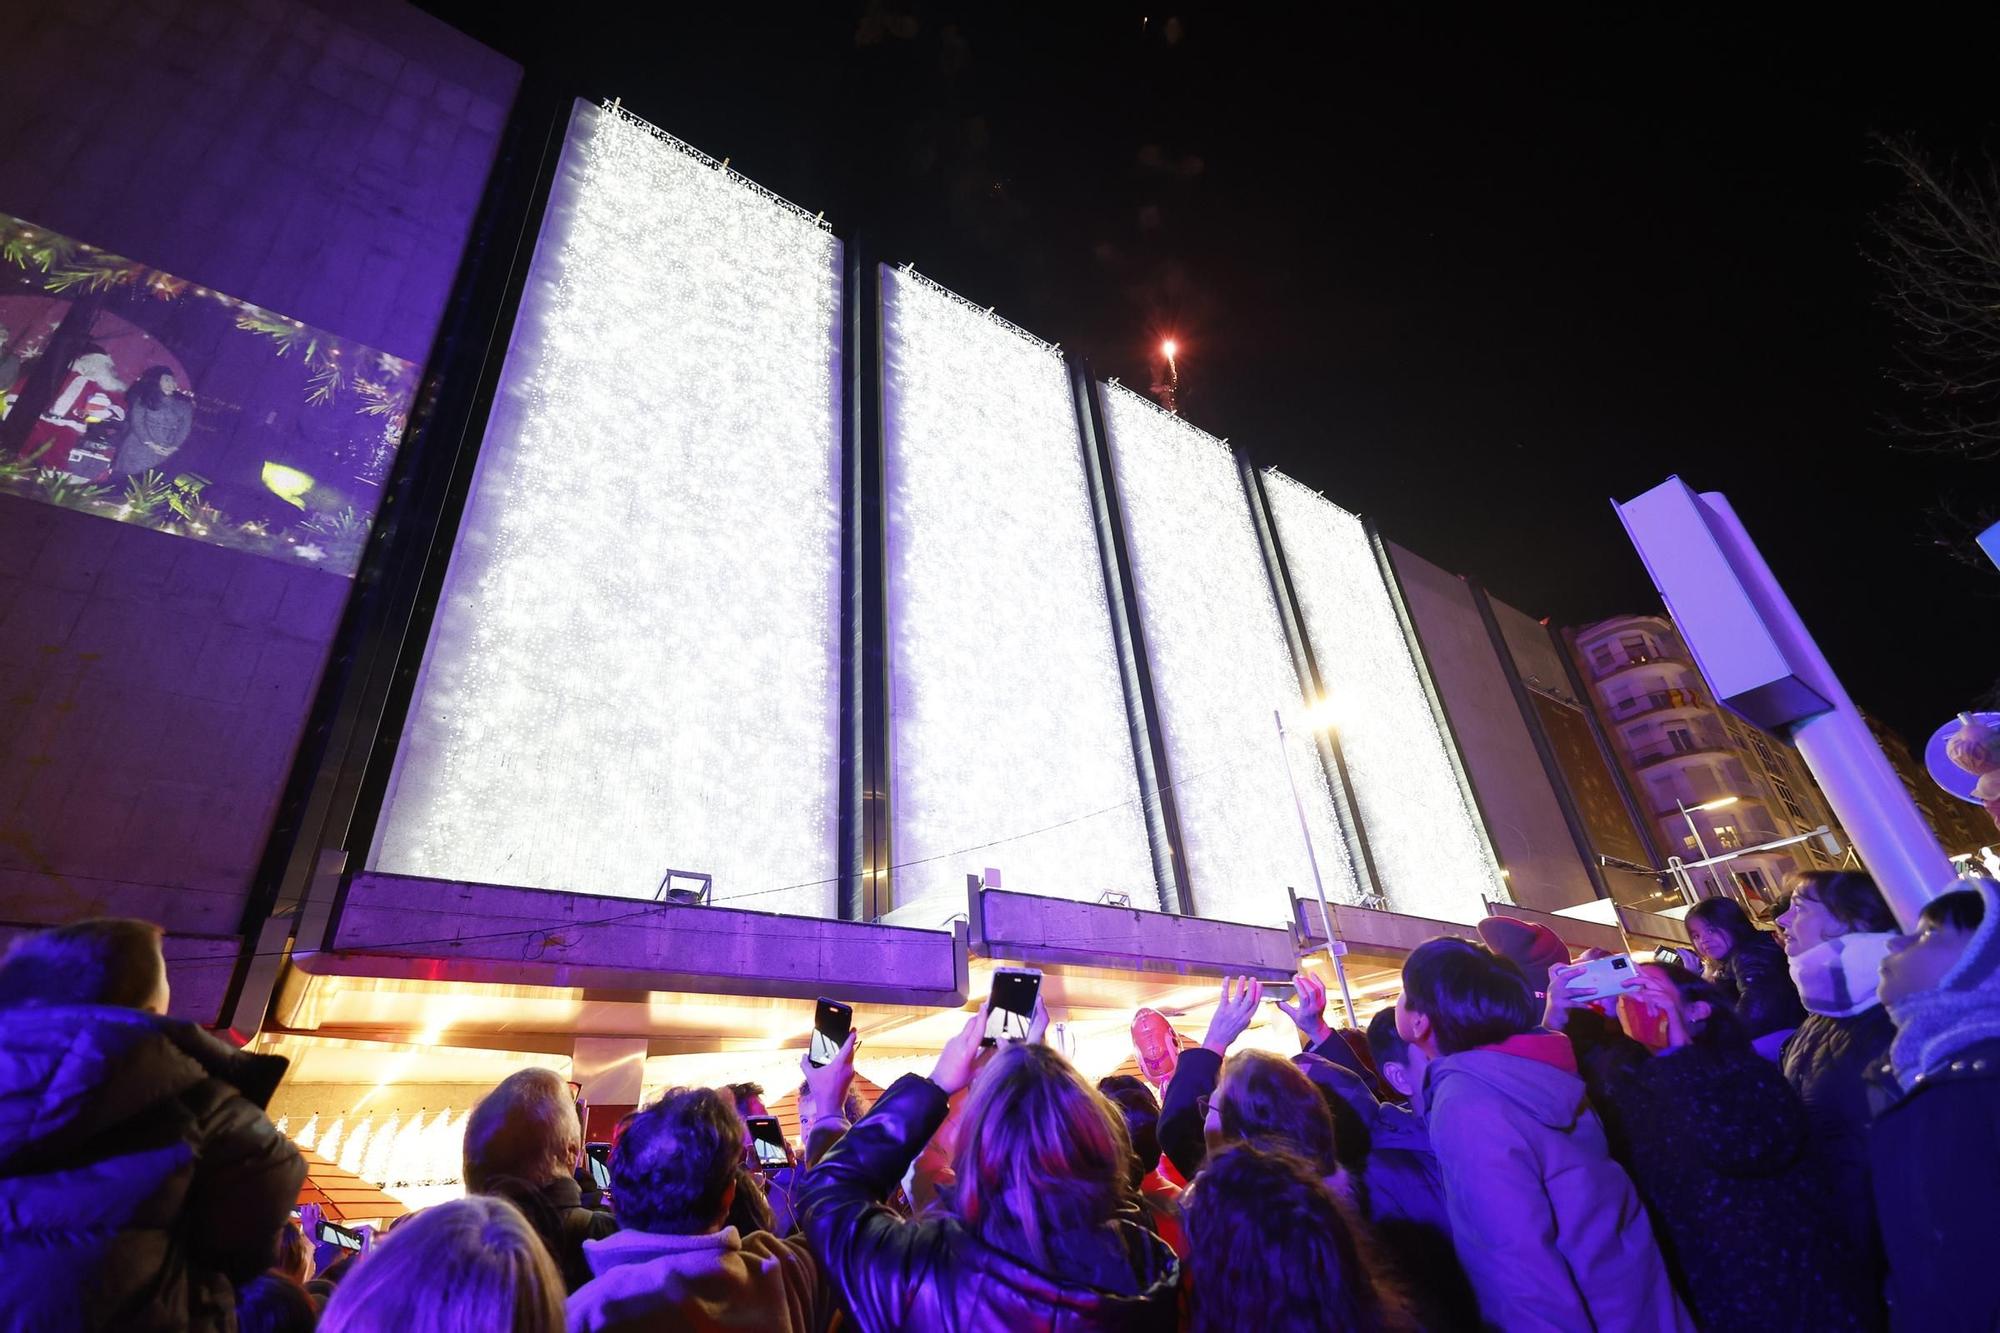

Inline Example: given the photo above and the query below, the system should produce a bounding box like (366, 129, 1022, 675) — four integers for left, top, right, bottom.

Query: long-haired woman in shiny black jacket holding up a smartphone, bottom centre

(798, 980, 1180, 1333)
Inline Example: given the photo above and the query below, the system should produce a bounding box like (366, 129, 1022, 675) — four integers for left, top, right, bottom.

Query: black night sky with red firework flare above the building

(414, 2, 2000, 745)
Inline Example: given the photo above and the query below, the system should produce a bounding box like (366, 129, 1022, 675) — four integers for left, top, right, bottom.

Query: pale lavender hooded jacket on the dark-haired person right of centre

(1424, 1033, 1694, 1333)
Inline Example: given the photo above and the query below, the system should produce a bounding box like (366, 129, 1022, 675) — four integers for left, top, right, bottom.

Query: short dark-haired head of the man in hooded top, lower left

(612, 1087, 744, 1235)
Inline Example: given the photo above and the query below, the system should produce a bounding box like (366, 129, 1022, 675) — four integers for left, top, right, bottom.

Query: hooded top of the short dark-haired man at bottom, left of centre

(568, 1227, 828, 1333)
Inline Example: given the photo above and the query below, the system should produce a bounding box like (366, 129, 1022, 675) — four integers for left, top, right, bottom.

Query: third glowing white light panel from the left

(1104, 384, 1360, 925)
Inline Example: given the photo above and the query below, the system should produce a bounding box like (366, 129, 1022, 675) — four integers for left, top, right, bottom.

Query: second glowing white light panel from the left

(882, 272, 1158, 907)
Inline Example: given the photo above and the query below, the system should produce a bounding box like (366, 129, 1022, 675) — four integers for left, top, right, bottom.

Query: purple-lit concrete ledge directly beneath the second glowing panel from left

(968, 883, 1298, 981)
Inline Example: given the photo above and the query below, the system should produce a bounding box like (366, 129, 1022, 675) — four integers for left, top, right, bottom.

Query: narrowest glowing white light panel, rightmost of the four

(1264, 470, 1506, 923)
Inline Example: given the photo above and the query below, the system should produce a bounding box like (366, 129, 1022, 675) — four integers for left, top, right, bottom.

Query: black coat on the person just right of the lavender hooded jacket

(1590, 1041, 1872, 1333)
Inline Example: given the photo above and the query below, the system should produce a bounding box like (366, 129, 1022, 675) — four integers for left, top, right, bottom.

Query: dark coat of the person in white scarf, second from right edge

(1784, 1005, 1896, 1287)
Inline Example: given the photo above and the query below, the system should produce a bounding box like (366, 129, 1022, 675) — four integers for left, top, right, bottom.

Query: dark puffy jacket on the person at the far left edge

(0, 1005, 306, 1333)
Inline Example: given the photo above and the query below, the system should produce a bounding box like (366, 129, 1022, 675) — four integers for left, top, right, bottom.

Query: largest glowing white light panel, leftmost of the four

(374, 104, 840, 915)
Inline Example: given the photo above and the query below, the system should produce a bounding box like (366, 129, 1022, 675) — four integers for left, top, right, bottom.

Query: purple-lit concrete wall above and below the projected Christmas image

(0, 0, 520, 1019)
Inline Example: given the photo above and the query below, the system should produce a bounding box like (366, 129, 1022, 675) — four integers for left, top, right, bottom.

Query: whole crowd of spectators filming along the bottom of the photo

(0, 873, 2000, 1333)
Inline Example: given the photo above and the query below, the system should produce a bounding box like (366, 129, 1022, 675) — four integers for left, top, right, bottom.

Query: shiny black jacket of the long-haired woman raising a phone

(798, 1075, 1180, 1333)
